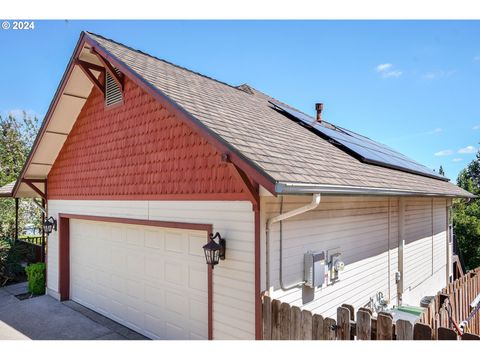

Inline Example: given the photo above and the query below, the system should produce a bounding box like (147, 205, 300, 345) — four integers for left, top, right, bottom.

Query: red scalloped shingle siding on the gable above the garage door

(48, 79, 247, 200)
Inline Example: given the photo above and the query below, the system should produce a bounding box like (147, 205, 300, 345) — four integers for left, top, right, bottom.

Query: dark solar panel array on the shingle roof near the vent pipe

(269, 101, 448, 181)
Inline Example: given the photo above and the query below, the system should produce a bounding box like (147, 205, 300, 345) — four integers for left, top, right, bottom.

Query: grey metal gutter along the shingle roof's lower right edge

(275, 182, 476, 199)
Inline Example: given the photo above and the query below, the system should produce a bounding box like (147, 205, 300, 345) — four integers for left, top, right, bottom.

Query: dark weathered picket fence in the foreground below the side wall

(263, 296, 480, 340)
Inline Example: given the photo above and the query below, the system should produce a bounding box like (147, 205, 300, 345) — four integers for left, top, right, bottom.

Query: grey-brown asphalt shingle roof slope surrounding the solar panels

(88, 33, 470, 197)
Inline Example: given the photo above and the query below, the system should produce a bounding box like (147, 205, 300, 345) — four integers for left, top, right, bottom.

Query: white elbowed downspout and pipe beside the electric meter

(265, 194, 321, 291)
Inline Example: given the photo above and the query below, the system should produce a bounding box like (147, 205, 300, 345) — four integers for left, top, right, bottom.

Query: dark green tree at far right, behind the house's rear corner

(453, 151, 480, 269)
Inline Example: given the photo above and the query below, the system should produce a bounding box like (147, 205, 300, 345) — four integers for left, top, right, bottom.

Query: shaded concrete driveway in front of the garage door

(0, 283, 146, 340)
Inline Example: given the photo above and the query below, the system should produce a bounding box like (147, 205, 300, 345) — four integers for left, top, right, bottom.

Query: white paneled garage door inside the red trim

(70, 220, 208, 339)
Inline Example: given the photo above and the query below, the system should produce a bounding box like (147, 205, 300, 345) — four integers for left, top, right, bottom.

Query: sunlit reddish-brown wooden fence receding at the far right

(420, 268, 480, 335)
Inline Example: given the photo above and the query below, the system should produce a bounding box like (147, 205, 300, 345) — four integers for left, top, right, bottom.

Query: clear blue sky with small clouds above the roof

(0, 21, 480, 180)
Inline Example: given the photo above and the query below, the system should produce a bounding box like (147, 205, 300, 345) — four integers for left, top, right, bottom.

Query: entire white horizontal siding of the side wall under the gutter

(261, 196, 446, 317)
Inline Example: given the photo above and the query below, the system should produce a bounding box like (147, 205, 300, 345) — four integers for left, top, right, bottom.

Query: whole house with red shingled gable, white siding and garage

(1, 32, 471, 339)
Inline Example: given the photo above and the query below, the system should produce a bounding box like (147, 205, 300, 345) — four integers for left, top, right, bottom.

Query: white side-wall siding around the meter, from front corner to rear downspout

(262, 196, 398, 316)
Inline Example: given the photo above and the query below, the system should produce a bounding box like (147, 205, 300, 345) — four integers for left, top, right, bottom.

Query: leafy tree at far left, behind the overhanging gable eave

(0, 111, 40, 238)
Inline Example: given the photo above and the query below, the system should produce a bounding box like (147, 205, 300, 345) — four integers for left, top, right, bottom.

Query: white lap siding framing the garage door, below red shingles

(47, 200, 255, 339)
